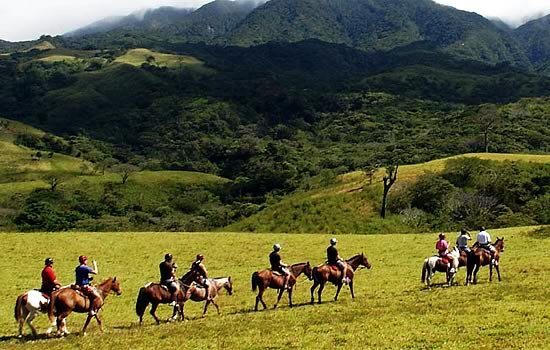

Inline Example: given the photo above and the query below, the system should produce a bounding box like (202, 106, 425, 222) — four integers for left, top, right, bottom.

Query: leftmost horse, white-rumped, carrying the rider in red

(14, 289, 55, 338)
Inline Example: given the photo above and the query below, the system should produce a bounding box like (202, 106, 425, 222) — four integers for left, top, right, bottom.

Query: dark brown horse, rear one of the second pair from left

(136, 270, 198, 324)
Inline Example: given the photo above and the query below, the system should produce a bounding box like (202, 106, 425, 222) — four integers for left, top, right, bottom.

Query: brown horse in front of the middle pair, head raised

(311, 253, 371, 304)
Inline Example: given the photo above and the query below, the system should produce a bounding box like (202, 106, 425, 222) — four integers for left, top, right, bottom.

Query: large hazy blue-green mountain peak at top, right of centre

(227, 0, 529, 67)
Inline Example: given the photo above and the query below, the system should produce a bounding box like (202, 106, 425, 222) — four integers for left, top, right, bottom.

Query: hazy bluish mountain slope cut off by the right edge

(514, 15, 550, 73)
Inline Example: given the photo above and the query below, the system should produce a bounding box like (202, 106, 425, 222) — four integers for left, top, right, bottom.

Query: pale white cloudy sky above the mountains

(0, 0, 550, 41)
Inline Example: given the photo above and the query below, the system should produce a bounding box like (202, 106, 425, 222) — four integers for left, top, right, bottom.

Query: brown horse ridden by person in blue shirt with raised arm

(48, 277, 122, 335)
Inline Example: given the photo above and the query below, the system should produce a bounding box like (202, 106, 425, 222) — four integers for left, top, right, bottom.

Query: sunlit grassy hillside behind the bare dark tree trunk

(230, 153, 550, 233)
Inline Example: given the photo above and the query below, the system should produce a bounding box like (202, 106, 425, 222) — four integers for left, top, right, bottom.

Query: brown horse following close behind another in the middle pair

(252, 261, 312, 311)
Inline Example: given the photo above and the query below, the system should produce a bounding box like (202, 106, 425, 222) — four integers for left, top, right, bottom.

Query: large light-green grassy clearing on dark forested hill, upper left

(115, 49, 216, 73)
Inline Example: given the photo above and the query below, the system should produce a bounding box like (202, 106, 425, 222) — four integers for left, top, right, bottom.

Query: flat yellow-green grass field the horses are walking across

(0, 228, 550, 349)
